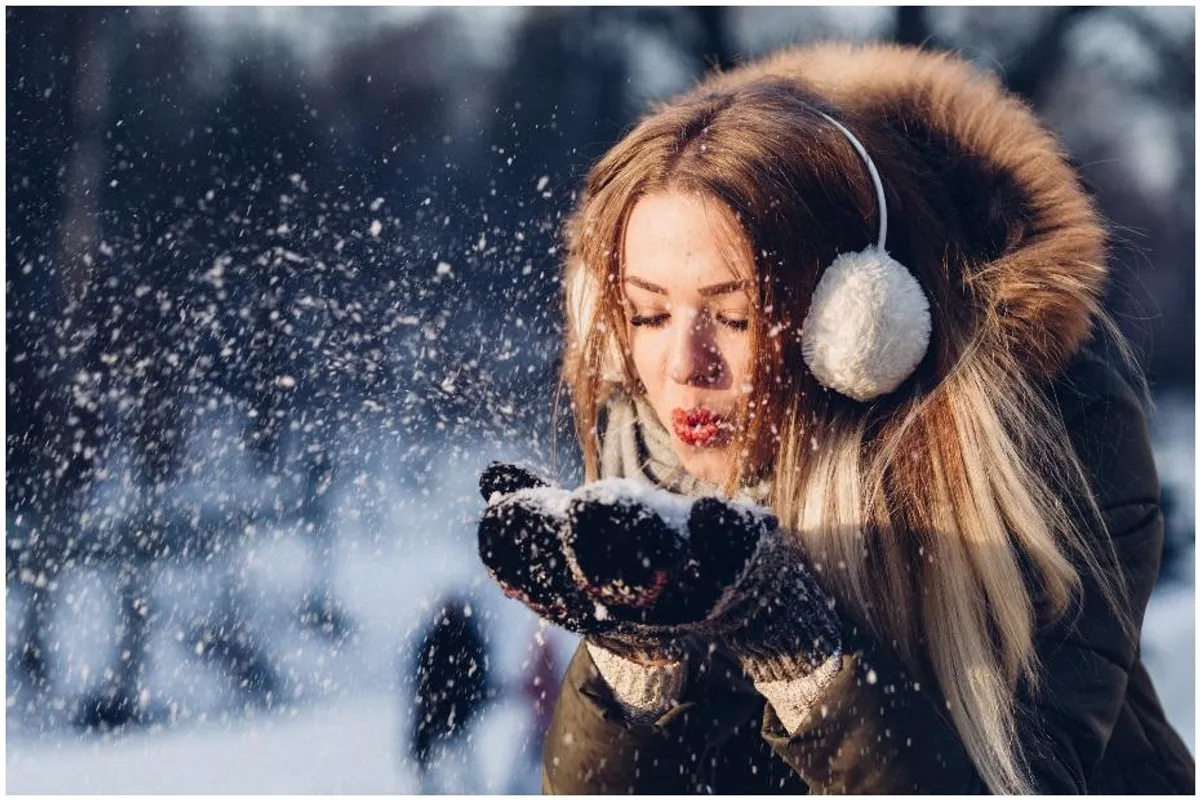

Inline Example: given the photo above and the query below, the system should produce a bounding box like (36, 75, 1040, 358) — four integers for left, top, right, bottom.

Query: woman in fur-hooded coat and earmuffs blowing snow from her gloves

(480, 44, 1194, 794)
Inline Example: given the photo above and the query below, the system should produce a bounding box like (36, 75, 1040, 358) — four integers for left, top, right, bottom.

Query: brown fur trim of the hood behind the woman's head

(701, 43, 1108, 379)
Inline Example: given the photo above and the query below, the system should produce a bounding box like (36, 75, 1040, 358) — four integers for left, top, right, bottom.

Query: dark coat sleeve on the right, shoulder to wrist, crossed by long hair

(763, 355, 1163, 794)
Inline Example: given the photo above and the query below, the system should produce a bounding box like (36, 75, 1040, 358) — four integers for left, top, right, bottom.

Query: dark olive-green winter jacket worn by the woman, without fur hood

(542, 350, 1195, 794)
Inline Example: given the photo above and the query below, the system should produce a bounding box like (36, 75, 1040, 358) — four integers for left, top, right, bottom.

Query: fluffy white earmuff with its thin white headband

(800, 113, 932, 402)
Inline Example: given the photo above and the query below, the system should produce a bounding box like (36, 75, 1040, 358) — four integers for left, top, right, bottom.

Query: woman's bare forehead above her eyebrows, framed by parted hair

(622, 191, 752, 289)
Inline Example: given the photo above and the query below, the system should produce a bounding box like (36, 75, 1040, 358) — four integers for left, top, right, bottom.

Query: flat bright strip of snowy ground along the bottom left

(7, 693, 536, 794)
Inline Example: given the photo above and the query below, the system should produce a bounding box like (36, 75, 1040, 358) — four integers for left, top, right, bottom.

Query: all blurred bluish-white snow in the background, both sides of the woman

(6, 397, 1195, 794)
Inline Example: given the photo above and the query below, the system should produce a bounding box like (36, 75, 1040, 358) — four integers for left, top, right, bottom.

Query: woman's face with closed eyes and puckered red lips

(623, 191, 754, 483)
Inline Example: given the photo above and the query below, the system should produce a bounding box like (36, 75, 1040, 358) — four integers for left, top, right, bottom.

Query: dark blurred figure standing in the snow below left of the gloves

(408, 596, 496, 794)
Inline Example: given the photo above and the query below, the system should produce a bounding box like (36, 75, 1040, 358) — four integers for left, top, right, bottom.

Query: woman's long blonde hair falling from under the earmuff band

(563, 47, 1123, 793)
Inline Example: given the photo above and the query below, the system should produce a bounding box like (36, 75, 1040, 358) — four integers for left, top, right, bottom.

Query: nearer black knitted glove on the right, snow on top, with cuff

(566, 480, 841, 684)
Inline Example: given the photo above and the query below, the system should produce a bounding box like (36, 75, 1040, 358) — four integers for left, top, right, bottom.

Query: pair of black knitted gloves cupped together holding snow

(480, 465, 841, 681)
